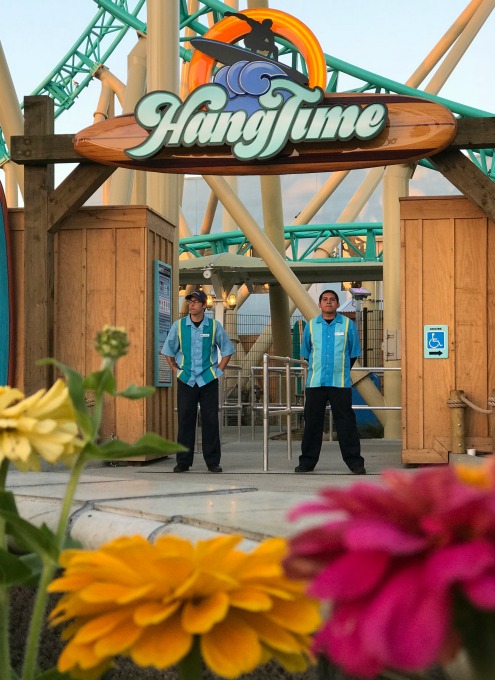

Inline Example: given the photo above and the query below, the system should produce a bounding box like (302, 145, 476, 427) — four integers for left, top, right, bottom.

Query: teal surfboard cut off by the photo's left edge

(0, 178, 14, 386)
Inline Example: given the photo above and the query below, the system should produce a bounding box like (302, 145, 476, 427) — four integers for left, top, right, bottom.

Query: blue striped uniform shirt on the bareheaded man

(301, 314, 361, 387)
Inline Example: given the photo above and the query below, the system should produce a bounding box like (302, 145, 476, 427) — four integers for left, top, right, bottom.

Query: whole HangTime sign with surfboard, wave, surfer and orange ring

(74, 9, 456, 175)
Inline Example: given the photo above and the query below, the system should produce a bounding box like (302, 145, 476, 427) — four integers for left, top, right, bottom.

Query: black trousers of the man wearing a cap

(177, 380, 221, 466)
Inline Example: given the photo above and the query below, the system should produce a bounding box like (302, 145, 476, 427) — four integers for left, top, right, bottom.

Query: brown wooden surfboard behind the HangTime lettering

(74, 95, 456, 175)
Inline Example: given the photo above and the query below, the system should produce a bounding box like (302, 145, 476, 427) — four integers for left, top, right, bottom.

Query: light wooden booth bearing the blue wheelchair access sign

(401, 196, 495, 463)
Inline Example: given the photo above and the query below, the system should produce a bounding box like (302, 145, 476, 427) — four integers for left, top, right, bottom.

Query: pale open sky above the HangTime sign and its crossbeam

(0, 0, 495, 139)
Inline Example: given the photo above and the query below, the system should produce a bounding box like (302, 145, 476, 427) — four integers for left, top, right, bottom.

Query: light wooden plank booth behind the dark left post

(9, 206, 175, 442)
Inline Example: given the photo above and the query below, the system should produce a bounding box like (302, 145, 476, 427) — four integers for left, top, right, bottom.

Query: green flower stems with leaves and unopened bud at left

(0, 327, 183, 680)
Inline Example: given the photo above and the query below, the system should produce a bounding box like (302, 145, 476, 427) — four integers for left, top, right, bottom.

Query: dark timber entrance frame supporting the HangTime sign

(6, 97, 495, 448)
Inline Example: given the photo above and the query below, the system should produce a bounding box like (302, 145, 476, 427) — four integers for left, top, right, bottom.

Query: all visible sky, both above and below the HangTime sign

(0, 0, 495, 310)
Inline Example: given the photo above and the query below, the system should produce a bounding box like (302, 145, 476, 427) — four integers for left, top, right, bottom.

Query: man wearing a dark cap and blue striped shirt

(162, 290, 235, 472)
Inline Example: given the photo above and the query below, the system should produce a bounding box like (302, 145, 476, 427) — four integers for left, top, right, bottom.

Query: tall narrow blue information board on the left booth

(154, 260, 172, 387)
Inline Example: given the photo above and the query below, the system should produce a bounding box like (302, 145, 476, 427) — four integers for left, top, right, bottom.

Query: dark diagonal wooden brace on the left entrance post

(48, 163, 117, 234)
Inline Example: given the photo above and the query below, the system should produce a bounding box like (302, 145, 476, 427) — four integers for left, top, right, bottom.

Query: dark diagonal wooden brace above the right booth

(430, 149, 495, 223)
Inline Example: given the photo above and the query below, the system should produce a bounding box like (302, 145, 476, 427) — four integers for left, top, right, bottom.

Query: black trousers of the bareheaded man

(299, 387, 364, 470)
